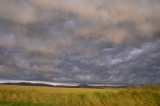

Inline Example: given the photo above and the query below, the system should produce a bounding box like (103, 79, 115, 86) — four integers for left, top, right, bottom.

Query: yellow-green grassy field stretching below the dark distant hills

(0, 85, 160, 106)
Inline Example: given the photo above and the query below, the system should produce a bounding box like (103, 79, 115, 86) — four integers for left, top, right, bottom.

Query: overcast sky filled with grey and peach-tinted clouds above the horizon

(0, 0, 160, 85)
